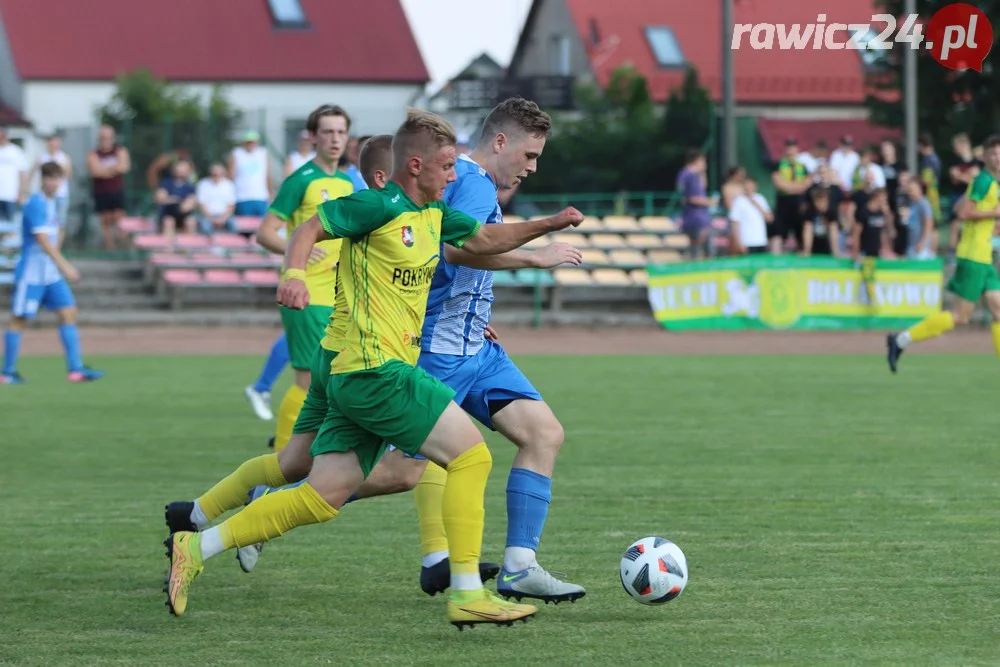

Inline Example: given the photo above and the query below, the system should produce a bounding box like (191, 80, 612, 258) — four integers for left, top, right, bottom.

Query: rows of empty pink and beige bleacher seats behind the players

(122, 215, 712, 308)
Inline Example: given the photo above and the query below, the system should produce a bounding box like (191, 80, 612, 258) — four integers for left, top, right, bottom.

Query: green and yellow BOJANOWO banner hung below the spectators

(647, 255, 943, 331)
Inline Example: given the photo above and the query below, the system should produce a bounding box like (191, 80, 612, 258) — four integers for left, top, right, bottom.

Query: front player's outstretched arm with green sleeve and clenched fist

(454, 206, 583, 255)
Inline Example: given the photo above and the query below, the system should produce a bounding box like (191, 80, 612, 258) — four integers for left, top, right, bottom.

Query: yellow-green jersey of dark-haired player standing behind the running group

(269, 160, 354, 306)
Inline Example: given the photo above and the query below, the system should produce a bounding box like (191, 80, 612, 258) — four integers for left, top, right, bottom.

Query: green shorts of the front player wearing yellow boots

(310, 359, 455, 477)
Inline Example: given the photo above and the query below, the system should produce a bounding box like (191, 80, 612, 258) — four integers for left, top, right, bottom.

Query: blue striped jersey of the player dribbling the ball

(420, 155, 503, 356)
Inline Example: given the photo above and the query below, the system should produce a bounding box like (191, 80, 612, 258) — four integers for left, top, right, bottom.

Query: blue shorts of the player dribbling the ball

(390, 340, 542, 459)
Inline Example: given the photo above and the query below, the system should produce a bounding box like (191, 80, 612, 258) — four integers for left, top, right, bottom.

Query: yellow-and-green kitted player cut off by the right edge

(887, 135, 1000, 373)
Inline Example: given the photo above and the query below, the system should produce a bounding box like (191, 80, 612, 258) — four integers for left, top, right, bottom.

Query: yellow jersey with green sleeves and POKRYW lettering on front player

(317, 182, 480, 375)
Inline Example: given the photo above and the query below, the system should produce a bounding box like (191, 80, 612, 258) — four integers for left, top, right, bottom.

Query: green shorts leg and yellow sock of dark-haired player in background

(274, 306, 333, 452)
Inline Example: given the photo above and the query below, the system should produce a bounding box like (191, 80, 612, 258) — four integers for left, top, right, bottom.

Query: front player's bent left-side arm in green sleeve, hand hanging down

(278, 190, 390, 310)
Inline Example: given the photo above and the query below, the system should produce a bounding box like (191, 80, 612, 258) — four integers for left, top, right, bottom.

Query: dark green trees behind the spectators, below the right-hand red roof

(523, 67, 711, 194)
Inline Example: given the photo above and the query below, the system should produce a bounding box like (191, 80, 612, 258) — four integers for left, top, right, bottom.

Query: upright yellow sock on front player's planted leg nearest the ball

(441, 442, 493, 589)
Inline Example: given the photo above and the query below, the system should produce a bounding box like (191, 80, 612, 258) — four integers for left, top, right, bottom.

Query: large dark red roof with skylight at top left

(0, 0, 429, 83)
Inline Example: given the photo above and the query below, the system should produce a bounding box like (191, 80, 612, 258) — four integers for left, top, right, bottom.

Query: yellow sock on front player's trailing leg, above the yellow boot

(219, 483, 339, 549)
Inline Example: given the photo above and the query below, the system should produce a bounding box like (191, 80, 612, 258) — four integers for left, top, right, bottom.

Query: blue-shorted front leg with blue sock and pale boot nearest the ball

(462, 341, 586, 603)
